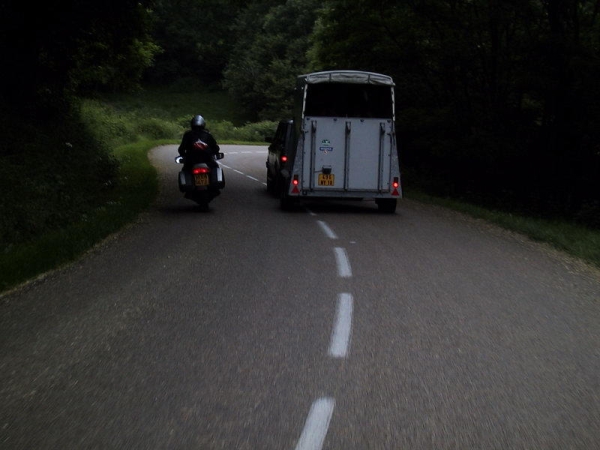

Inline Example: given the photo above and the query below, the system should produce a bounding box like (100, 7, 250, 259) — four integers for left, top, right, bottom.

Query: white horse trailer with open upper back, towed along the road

(280, 70, 402, 213)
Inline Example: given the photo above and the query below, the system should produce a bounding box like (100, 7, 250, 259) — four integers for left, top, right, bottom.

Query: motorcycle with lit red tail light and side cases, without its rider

(175, 153, 225, 210)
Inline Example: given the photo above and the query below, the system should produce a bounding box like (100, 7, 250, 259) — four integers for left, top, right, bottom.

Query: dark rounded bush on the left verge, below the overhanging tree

(0, 108, 117, 251)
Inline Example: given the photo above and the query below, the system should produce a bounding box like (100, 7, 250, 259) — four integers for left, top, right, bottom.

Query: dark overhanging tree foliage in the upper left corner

(0, 0, 157, 118)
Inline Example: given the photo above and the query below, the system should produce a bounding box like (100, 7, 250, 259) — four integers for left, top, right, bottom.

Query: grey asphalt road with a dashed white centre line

(0, 146, 600, 450)
